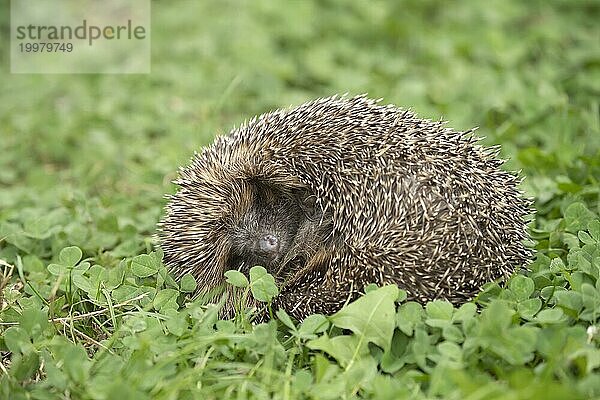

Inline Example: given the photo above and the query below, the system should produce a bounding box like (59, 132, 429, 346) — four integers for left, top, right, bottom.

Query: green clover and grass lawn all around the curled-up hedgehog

(0, 0, 600, 399)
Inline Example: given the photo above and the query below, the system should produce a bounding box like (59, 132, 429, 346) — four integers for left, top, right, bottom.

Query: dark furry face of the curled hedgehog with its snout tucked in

(227, 183, 315, 280)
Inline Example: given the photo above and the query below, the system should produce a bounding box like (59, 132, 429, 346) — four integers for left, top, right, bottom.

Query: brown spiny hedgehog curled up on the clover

(158, 95, 532, 319)
